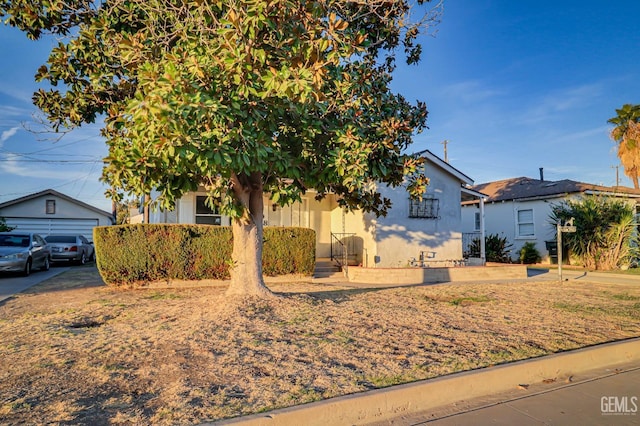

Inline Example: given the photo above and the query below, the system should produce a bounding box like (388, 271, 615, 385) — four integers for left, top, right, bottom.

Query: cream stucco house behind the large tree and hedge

(149, 151, 482, 267)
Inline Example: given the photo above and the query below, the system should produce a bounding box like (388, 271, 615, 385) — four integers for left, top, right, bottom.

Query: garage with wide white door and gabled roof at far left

(0, 189, 114, 240)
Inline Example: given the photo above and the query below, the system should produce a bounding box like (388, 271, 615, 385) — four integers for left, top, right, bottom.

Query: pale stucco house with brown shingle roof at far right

(462, 174, 640, 261)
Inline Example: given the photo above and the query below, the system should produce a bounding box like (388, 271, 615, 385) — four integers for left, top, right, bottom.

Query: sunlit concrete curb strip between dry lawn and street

(212, 338, 640, 426)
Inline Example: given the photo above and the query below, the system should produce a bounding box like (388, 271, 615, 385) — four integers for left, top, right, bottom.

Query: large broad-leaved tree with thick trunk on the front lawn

(0, 0, 439, 297)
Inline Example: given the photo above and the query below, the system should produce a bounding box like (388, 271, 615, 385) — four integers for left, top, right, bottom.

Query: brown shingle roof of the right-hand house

(472, 177, 640, 202)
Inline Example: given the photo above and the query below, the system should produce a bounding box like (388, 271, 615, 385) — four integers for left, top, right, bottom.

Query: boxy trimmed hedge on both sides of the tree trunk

(93, 224, 316, 286)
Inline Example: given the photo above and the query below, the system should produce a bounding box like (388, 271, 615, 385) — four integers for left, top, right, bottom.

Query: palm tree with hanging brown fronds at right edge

(607, 104, 640, 189)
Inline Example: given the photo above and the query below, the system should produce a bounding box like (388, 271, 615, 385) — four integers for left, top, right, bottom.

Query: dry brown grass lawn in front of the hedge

(0, 266, 640, 425)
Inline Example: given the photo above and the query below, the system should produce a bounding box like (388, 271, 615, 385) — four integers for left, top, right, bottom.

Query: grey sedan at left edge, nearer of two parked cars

(0, 232, 50, 276)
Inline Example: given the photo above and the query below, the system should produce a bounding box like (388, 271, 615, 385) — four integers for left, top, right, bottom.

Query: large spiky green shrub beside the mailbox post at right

(549, 196, 638, 270)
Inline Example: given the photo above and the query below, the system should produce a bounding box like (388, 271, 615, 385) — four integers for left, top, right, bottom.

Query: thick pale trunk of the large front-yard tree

(227, 173, 274, 298)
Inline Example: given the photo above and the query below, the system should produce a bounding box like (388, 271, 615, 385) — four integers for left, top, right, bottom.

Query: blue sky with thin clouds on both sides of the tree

(0, 0, 640, 210)
